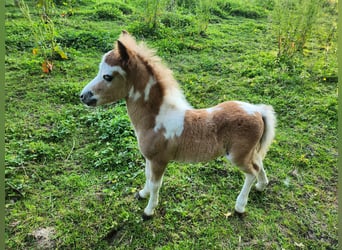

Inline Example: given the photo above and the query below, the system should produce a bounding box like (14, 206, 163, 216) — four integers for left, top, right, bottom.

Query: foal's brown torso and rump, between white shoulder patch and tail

(174, 101, 264, 162)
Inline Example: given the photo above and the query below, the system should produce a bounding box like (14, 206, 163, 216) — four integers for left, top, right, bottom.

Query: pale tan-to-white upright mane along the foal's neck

(119, 32, 191, 109)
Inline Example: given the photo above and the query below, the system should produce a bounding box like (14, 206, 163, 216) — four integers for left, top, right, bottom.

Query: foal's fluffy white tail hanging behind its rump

(258, 104, 277, 159)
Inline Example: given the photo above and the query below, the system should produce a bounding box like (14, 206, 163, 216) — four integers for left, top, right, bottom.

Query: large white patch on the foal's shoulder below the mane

(154, 86, 191, 139)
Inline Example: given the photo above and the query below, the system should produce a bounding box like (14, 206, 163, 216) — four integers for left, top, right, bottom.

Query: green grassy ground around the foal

(5, 0, 338, 249)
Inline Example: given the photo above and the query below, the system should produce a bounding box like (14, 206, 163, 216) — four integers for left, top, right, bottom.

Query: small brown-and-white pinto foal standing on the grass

(80, 31, 276, 219)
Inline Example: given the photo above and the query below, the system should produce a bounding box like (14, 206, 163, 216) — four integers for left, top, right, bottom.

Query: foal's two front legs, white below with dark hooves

(139, 160, 166, 219)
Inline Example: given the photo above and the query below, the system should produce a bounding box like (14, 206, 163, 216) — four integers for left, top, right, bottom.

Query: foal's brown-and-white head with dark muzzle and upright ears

(80, 31, 131, 107)
